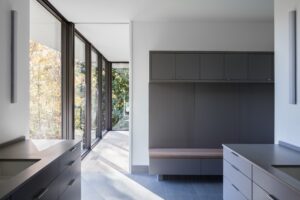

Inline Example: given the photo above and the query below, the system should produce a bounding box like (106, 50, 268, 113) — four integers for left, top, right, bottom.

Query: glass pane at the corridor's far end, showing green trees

(112, 63, 129, 131)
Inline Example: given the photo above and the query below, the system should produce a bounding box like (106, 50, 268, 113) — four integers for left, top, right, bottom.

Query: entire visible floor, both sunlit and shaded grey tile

(81, 131, 222, 200)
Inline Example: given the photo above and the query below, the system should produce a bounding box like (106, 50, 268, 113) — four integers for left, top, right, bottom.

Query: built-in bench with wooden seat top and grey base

(149, 148, 223, 180)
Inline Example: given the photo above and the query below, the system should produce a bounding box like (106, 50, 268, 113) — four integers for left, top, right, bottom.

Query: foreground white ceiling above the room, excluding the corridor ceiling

(50, 0, 274, 23)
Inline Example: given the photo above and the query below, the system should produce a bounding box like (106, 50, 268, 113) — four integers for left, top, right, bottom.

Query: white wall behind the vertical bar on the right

(275, 0, 300, 146)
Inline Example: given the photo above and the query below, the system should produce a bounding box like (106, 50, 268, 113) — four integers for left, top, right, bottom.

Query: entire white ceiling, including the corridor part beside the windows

(49, 0, 274, 61)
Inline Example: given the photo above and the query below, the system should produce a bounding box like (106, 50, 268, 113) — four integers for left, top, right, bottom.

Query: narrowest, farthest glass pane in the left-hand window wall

(101, 59, 107, 134)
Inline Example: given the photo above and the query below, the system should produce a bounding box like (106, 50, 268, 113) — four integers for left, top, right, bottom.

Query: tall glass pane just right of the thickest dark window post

(74, 37, 86, 148)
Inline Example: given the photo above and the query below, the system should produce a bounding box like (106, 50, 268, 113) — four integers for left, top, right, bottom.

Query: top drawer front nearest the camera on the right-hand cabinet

(253, 167, 300, 200)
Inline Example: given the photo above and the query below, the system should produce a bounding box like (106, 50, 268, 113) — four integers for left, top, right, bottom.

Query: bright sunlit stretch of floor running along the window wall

(82, 132, 163, 200)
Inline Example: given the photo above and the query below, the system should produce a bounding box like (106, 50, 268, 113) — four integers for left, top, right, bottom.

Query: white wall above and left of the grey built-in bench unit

(131, 22, 274, 165)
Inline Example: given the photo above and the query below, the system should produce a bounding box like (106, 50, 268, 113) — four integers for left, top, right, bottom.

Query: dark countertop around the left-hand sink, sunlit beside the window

(0, 140, 80, 199)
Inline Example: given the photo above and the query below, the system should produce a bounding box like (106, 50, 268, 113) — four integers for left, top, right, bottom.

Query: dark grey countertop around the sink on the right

(223, 144, 300, 195)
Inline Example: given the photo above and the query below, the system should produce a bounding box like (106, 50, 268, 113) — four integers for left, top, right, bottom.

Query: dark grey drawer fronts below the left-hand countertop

(11, 144, 81, 200)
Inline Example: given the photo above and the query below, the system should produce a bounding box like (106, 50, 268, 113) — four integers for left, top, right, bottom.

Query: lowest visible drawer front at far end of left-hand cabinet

(59, 176, 81, 200)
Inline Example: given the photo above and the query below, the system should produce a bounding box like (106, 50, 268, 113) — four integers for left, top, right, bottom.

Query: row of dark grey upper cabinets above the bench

(150, 51, 274, 83)
